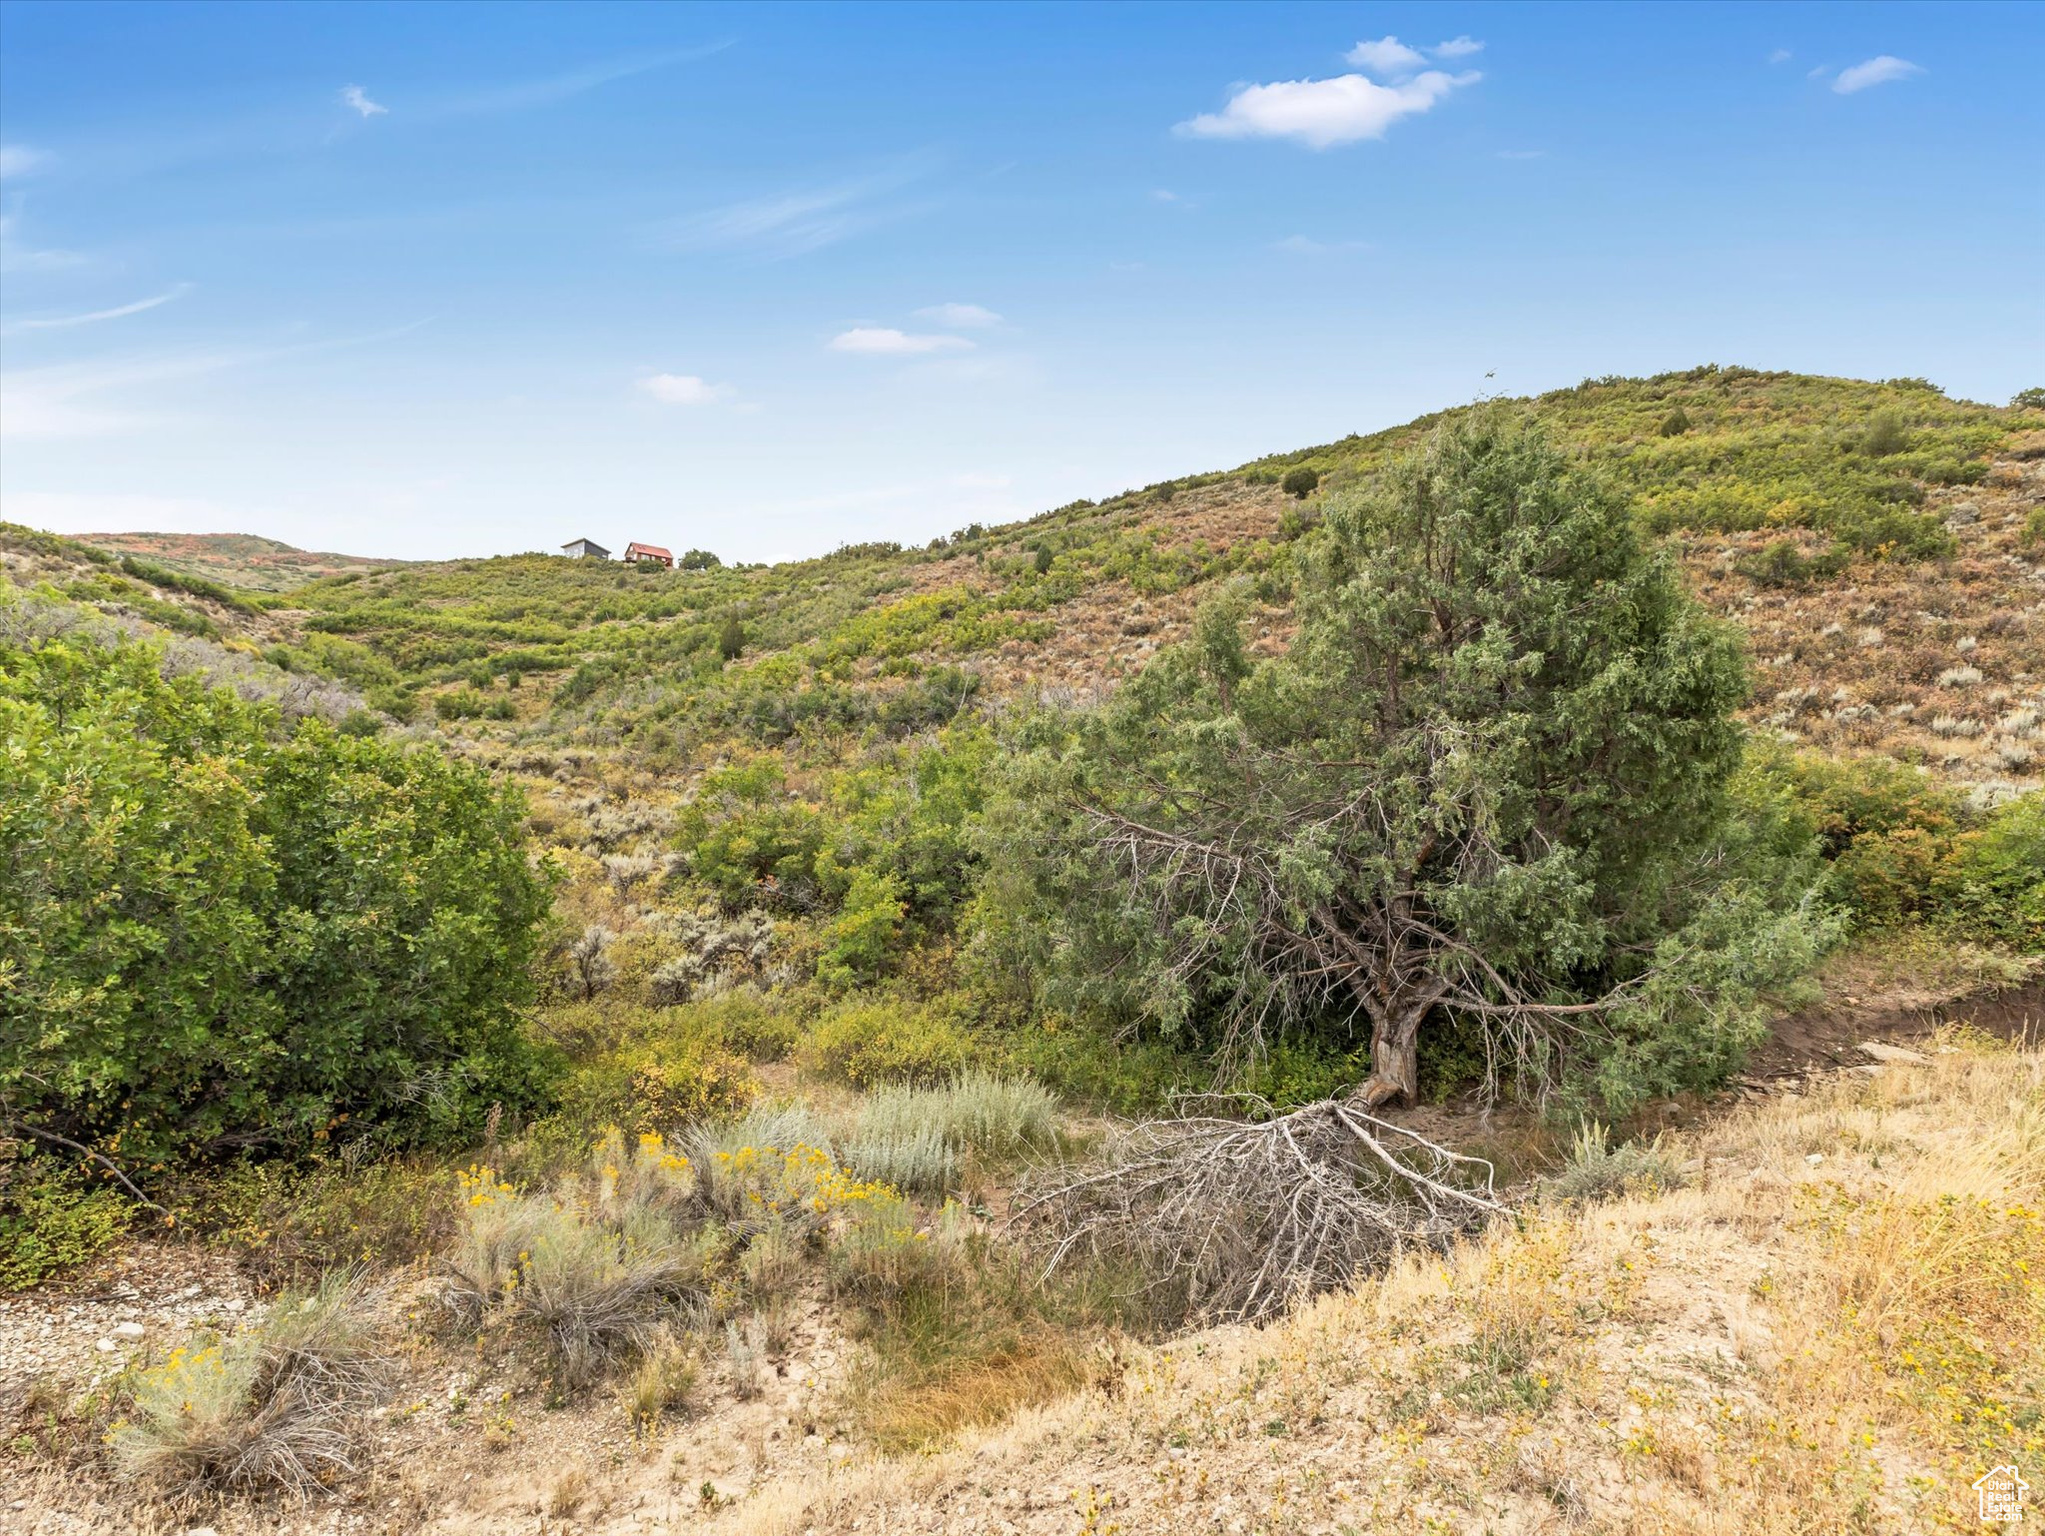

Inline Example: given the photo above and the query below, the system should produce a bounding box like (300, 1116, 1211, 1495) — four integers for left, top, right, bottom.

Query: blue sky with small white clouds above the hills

(0, 0, 2045, 558)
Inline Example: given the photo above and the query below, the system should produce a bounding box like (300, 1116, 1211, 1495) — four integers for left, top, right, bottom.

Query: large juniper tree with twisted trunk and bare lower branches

(990, 413, 1812, 1104)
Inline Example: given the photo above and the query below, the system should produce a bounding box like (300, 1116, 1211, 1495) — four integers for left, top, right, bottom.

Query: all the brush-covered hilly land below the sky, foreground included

(0, 366, 2045, 1536)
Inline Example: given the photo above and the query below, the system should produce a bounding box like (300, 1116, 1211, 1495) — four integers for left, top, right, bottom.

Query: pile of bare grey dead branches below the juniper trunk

(1012, 1098, 1505, 1321)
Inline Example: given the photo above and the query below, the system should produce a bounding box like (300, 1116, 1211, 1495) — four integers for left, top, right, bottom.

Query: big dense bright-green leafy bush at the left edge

(0, 636, 550, 1162)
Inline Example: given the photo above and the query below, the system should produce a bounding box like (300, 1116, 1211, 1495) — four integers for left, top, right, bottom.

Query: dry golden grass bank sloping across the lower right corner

(720, 1039, 2045, 1536)
